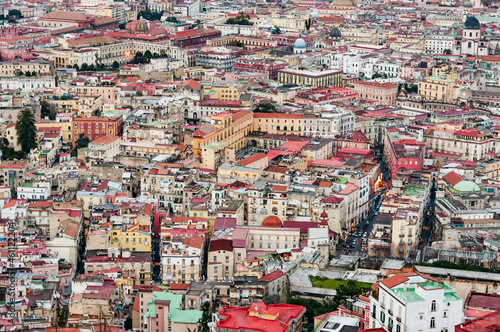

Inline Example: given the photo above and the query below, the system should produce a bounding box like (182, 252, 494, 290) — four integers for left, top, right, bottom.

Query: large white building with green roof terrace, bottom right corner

(369, 273, 463, 332)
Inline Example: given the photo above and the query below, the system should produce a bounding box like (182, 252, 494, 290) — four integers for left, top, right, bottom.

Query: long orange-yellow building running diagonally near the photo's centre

(193, 111, 253, 156)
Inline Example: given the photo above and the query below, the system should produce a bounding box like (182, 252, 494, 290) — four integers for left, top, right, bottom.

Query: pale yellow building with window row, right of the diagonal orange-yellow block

(253, 113, 303, 135)
